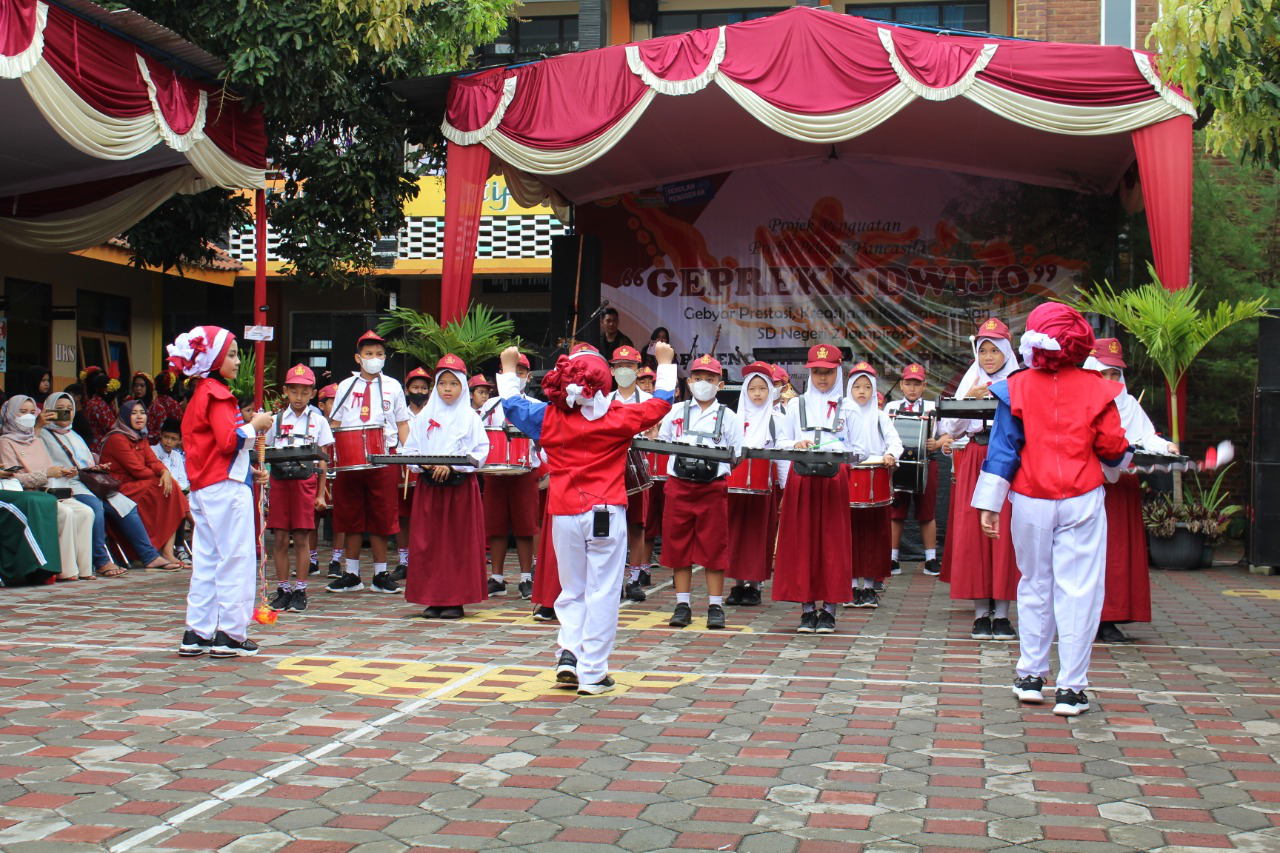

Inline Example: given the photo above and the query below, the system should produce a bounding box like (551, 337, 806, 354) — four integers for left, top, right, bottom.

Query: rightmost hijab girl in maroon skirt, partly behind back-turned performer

(1084, 338, 1179, 643)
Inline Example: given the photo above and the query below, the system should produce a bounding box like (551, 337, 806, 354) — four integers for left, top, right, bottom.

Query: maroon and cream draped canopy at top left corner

(0, 0, 266, 251)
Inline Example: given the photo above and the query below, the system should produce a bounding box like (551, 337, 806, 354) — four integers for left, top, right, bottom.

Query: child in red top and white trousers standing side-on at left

(168, 325, 271, 657)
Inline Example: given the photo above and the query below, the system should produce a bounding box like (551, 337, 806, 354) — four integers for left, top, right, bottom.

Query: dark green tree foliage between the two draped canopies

(117, 0, 516, 283)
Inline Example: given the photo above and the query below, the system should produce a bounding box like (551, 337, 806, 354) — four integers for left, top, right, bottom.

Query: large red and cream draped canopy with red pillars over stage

(442, 6, 1194, 320)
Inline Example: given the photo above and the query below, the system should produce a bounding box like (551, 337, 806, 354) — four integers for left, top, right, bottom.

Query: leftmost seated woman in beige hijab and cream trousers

(0, 394, 93, 580)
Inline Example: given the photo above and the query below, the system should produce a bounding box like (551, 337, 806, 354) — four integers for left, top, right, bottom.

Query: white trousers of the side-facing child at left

(187, 480, 257, 642)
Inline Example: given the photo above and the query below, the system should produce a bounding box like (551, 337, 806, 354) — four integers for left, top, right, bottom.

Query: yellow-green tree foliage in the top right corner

(1151, 0, 1280, 168)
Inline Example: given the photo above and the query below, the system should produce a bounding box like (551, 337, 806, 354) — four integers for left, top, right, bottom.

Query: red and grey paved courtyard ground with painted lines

(0, 548, 1280, 853)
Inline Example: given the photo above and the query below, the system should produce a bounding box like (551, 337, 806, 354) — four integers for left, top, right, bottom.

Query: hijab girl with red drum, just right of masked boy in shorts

(724, 361, 786, 607)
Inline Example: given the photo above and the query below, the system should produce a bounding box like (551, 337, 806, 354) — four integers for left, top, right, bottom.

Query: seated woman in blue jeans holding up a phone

(38, 392, 182, 578)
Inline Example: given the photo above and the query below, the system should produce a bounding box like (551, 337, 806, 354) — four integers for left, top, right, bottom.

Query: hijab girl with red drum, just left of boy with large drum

(846, 361, 902, 607)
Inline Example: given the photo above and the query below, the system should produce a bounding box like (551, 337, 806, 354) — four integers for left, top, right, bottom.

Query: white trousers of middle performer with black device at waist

(552, 506, 627, 684)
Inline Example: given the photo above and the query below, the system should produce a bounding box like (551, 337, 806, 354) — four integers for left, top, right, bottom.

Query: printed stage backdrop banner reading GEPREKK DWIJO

(577, 159, 1116, 382)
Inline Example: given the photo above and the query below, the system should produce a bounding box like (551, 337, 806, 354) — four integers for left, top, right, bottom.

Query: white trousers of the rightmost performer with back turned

(1009, 487, 1107, 690)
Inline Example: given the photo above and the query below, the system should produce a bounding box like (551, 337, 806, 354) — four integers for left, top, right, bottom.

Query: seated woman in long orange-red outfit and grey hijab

(99, 400, 189, 567)
